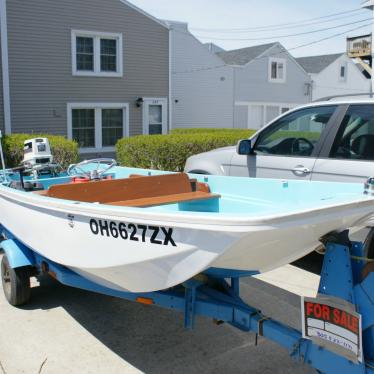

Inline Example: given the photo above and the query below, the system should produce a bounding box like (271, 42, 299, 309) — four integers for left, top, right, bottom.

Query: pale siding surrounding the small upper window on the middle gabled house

(235, 45, 310, 103)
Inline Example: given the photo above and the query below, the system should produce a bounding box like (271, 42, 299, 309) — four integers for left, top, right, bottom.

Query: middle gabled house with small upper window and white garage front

(217, 42, 311, 129)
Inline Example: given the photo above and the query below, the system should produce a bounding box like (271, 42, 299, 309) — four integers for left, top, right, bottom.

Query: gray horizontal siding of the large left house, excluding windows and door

(7, 0, 169, 135)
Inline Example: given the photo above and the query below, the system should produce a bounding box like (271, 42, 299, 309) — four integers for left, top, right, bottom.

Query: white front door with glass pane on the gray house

(143, 98, 168, 135)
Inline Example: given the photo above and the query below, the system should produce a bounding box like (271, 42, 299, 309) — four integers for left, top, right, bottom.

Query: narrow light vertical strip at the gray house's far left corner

(0, 0, 12, 134)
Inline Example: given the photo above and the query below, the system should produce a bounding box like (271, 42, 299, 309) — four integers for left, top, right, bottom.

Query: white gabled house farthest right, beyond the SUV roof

(296, 53, 370, 100)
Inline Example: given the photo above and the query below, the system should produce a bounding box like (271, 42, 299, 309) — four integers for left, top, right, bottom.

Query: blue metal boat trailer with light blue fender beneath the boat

(0, 225, 374, 374)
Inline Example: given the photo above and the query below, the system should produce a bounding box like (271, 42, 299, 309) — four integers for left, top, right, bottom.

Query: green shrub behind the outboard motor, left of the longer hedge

(3, 134, 79, 169)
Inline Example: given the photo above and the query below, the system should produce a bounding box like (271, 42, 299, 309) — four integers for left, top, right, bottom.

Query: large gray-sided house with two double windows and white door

(0, 0, 170, 153)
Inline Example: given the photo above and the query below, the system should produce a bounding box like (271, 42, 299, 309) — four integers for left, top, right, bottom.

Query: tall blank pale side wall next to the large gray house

(171, 23, 233, 128)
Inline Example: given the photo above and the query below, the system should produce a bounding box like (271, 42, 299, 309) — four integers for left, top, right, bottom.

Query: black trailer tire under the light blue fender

(1, 255, 31, 306)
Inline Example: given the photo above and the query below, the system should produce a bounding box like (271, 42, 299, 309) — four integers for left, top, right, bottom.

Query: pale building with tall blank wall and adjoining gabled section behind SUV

(166, 21, 311, 129)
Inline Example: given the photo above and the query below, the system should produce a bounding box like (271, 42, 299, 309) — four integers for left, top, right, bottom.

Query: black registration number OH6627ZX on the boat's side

(90, 218, 177, 247)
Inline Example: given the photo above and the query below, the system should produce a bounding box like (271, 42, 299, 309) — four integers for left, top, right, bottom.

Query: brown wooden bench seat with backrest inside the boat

(46, 173, 220, 207)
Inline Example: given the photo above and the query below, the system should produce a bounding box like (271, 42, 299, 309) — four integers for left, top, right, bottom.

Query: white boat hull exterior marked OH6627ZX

(0, 181, 374, 292)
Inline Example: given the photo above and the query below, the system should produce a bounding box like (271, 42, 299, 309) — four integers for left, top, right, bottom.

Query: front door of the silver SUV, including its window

(230, 105, 336, 180)
